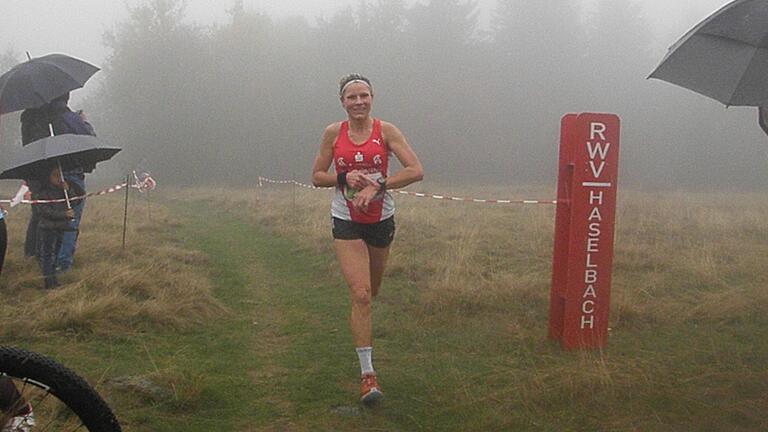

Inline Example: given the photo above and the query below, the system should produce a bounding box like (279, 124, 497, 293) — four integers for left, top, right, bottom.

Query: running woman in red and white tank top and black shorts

(312, 74, 423, 404)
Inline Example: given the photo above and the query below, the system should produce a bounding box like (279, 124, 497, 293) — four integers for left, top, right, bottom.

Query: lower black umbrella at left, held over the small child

(0, 134, 121, 180)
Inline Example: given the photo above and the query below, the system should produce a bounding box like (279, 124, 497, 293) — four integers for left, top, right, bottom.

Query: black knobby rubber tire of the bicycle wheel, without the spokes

(0, 346, 121, 432)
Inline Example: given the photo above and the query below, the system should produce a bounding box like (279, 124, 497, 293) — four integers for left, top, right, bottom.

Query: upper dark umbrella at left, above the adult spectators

(0, 54, 99, 114)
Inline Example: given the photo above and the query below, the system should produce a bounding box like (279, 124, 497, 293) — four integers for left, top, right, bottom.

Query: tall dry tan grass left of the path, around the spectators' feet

(0, 192, 226, 337)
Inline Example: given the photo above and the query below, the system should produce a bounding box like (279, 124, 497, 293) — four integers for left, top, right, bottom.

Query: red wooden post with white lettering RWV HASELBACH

(549, 113, 620, 349)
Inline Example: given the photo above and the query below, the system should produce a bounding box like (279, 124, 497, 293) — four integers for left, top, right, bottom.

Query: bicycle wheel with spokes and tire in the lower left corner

(0, 346, 121, 432)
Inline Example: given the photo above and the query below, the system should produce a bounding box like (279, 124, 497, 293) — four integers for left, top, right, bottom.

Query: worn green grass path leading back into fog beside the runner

(170, 207, 398, 431)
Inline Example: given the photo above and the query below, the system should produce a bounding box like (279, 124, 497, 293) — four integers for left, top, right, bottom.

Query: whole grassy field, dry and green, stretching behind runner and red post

(0, 181, 768, 431)
